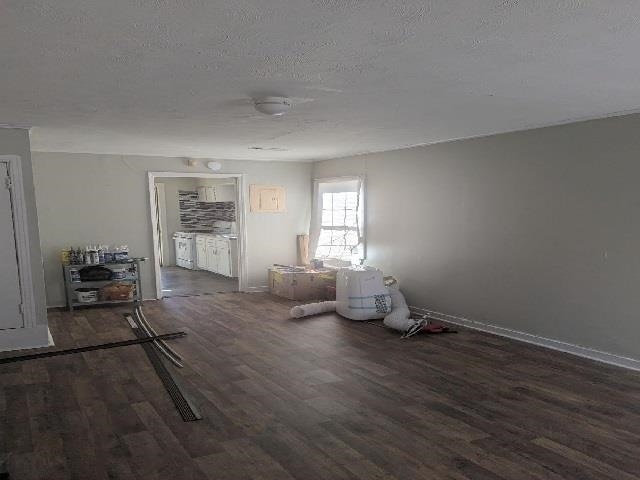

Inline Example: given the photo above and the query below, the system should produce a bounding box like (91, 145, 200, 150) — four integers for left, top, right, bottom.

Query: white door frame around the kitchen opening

(148, 172, 249, 299)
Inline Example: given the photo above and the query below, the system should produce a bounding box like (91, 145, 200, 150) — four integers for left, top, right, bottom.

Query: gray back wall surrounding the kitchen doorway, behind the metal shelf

(33, 152, 311, 305)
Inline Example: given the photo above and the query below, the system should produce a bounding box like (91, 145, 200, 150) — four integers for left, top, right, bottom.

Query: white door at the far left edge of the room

(0, 162, 24, 330)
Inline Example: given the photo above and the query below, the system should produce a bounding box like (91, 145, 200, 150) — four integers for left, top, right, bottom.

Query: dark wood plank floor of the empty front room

(0, 294, 640, 480)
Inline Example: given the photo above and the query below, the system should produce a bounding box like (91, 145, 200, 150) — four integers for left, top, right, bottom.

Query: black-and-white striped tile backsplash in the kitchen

(178, 190, 236, 230)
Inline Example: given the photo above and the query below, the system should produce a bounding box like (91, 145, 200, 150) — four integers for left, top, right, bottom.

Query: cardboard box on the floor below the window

(269, 267, 336, 300)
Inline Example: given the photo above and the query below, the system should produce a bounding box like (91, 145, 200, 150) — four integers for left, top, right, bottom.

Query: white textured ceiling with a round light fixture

(0, 0, 640, 160)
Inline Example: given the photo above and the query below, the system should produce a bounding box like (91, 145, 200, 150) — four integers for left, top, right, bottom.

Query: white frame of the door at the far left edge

(0, 155, 37, 328)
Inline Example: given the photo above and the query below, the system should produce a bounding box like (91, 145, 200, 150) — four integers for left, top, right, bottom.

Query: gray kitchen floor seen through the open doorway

(161, 267, 238, 297)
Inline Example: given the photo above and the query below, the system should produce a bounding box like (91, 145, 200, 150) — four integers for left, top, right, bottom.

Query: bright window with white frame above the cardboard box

(312, 178, 364, 262)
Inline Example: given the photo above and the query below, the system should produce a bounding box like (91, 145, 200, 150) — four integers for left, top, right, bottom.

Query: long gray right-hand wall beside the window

(314, 115, 640, 359)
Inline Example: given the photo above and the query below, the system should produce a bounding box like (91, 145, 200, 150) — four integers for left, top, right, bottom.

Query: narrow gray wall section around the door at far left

(0, 128, 47, 325)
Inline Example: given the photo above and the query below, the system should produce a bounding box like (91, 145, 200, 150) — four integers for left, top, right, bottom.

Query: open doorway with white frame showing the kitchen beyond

(149, 172, 246, 298)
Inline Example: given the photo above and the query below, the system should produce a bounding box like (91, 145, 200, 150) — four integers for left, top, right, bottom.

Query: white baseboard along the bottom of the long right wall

(409, 306, 640, 371)
